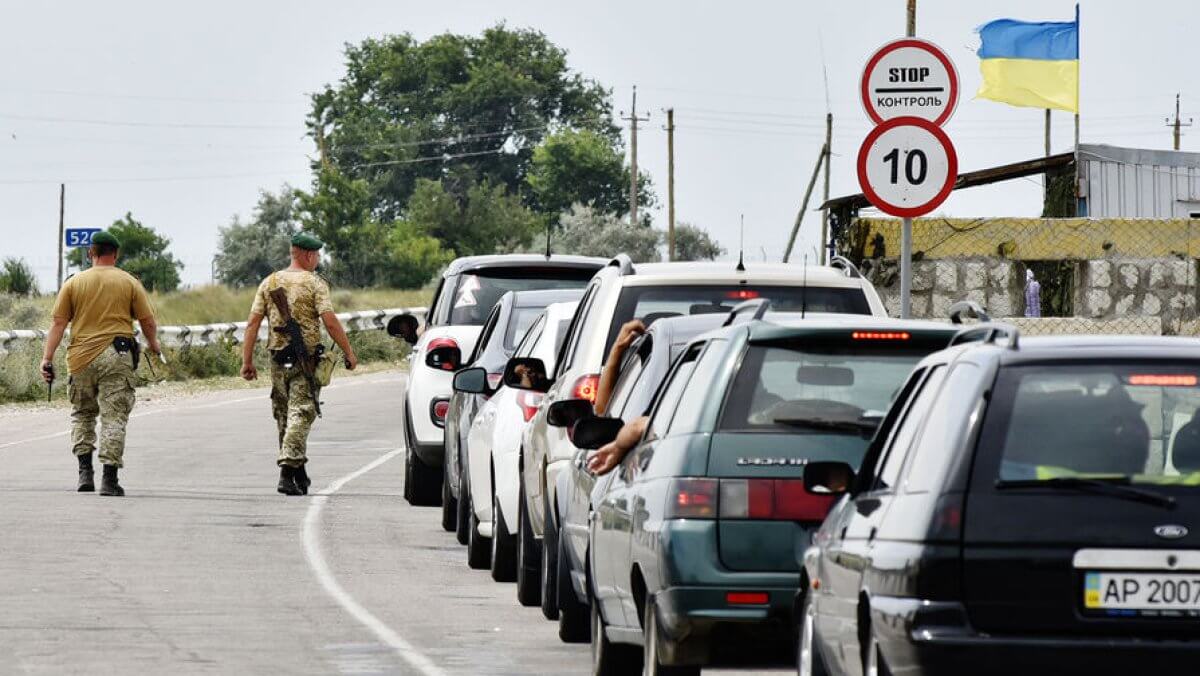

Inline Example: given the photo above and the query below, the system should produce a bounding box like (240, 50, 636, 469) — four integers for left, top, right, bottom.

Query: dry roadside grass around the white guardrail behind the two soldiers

(0, 286, 431, 403)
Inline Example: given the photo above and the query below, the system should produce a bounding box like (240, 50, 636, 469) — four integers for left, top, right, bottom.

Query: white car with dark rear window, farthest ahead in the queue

(388, 255, 605, 505)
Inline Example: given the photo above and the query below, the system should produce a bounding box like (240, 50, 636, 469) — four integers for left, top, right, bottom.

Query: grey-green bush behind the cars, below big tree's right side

(553, 204, 662, 263)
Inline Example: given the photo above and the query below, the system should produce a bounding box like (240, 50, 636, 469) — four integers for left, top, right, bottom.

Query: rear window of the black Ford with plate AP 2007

(985, 363, 1200, 485)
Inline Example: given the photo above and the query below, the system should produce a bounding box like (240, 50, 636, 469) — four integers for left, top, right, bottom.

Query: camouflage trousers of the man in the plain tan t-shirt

(71, 347, 138, 467)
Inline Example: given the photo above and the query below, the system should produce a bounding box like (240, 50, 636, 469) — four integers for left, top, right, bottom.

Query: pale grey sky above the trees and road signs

(0, 0, 1200, 291)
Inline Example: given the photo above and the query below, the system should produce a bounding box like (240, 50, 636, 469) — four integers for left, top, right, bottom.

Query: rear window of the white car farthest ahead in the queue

(450, 268, 595, 324)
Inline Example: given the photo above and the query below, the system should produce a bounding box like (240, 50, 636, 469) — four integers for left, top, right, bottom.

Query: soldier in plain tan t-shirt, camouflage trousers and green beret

(42, 231, 161, 496)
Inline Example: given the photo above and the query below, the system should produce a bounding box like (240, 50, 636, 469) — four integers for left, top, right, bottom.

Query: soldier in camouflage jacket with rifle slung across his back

(241, 233, 358, 495)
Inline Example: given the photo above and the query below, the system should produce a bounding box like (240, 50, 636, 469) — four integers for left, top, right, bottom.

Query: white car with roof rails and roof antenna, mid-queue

(506, 256, 887, 596)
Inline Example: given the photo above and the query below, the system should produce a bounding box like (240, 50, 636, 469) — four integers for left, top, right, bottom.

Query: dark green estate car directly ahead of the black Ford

(575, 311, 961, 674)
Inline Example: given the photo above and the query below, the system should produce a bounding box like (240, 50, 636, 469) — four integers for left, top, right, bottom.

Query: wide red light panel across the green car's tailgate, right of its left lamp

(720, 479, 836, 521)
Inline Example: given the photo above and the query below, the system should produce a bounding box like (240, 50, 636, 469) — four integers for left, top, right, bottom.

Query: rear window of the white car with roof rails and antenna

(605, 285, 871, 352)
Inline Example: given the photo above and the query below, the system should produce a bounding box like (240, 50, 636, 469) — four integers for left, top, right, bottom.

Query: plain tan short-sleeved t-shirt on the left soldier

(54, 265, 154, 373)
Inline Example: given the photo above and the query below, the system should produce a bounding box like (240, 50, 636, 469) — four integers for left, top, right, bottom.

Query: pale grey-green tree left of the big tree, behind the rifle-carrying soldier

(216, 185, 300, 287)
